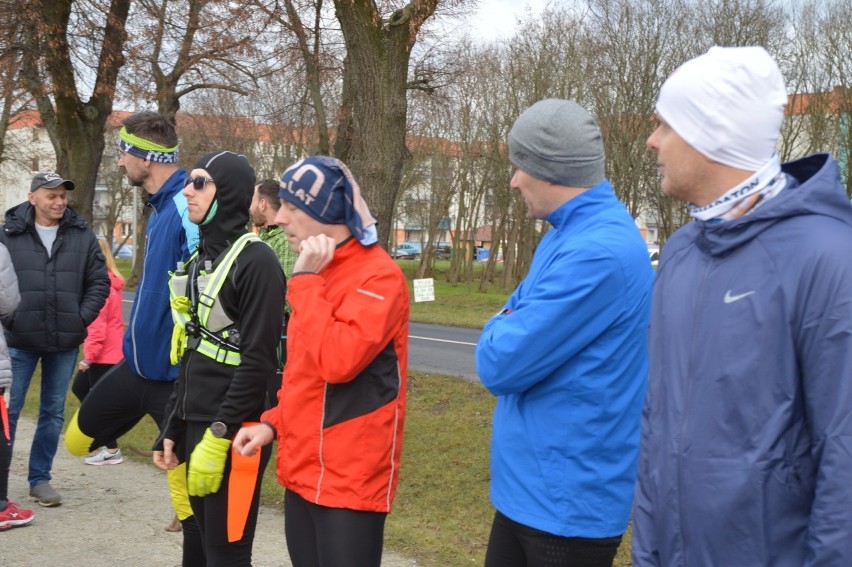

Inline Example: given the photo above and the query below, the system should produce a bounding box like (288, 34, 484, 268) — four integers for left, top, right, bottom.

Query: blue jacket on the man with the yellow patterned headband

(122, 169, 198, 381)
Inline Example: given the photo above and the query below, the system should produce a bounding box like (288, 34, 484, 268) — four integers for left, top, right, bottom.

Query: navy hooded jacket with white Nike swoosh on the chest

(633, 154, 852, 567)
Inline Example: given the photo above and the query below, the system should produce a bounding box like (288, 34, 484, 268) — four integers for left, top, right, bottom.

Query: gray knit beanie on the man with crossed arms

(509, 98, 606, 187)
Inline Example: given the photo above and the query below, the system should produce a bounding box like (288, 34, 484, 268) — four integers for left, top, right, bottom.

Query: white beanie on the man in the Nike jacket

(657, 47, 787, 171)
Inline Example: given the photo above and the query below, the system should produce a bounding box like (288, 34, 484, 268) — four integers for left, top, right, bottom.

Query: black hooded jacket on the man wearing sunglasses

(155, 152, 286, 450)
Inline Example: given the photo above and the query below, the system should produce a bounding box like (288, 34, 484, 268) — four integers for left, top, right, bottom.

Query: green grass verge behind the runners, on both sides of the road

(48, 260, 631, 567)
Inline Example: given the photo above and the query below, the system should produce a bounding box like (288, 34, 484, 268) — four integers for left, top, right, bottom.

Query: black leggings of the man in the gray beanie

(485, 512, 621, 567)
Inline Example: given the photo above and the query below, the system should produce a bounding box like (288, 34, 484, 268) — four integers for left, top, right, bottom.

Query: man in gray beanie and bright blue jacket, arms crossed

(476, 99, 653, 567)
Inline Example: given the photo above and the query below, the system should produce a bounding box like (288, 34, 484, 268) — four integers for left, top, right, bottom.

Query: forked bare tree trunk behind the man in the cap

(17, 0, 130, 221)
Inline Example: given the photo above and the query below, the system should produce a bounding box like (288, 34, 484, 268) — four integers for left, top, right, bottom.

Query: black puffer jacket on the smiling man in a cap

(0, 203, 109, 352)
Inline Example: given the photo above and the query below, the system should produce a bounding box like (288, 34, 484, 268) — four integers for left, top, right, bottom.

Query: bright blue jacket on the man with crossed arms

(476, 181, 653, 538)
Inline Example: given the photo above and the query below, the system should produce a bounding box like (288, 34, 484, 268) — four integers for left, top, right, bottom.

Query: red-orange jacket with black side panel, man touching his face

(262, 238, 409, 512)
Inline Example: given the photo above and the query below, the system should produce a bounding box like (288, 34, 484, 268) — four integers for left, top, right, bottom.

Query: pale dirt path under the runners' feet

(5, 418, 417, 567)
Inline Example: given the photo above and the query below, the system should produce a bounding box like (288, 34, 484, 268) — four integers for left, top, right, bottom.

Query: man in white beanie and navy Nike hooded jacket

(633, 46, 852, 567)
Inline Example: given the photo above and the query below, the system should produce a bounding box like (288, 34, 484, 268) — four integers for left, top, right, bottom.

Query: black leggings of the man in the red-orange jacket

(284, 490, 387, 567)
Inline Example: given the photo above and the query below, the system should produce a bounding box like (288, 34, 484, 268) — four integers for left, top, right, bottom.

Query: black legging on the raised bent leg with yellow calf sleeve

(77, 360, 175, 451)
